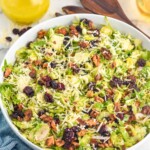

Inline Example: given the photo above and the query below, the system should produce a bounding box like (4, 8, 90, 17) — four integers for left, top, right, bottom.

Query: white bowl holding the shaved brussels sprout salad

(0, 14, 150, 150)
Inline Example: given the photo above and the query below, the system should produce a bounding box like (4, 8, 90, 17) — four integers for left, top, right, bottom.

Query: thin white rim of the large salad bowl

(0, 13, 150, 150)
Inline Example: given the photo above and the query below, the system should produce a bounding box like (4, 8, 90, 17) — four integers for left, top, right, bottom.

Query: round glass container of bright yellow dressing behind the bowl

(0, 0, 50, 24)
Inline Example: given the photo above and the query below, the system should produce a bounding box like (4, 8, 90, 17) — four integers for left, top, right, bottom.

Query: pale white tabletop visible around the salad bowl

(0, 0, 150, 150)
